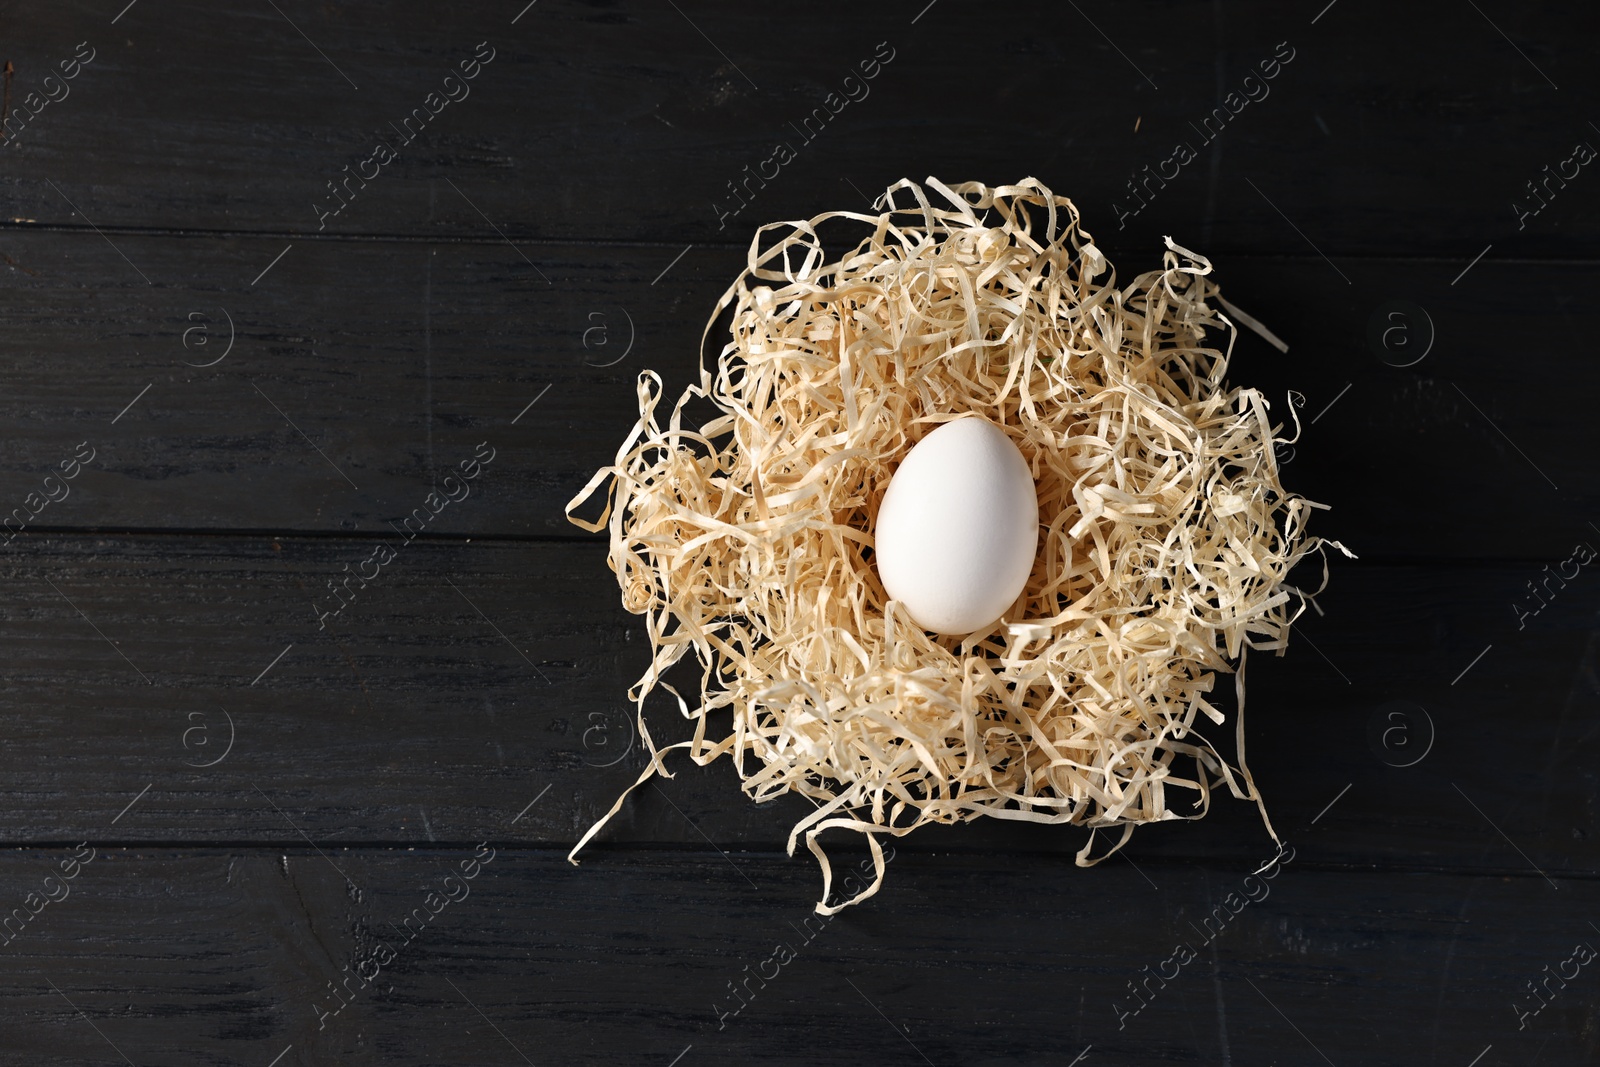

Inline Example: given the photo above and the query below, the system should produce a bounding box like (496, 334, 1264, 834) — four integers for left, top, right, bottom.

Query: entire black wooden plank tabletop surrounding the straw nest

(0, 0, 1600, 1067)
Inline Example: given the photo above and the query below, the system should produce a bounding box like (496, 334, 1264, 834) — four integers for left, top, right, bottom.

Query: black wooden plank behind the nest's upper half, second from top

(0, 234, 1600, 560)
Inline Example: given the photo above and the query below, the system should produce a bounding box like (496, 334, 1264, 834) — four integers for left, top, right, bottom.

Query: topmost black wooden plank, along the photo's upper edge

(5, 0, 1600, 259)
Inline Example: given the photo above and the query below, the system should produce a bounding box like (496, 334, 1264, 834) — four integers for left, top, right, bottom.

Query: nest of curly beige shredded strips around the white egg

(568, 178, 1342, 913)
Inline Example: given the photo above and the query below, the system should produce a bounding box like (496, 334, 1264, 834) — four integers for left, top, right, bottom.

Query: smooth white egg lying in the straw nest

(874, 416, 1038, 633)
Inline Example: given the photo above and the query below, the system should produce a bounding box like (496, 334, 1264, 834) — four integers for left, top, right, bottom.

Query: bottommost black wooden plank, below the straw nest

(0, 844, 1600, 1065)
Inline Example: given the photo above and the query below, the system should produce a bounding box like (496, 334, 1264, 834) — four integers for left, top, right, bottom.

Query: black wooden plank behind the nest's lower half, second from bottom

(0, 536, 1600, 878)
